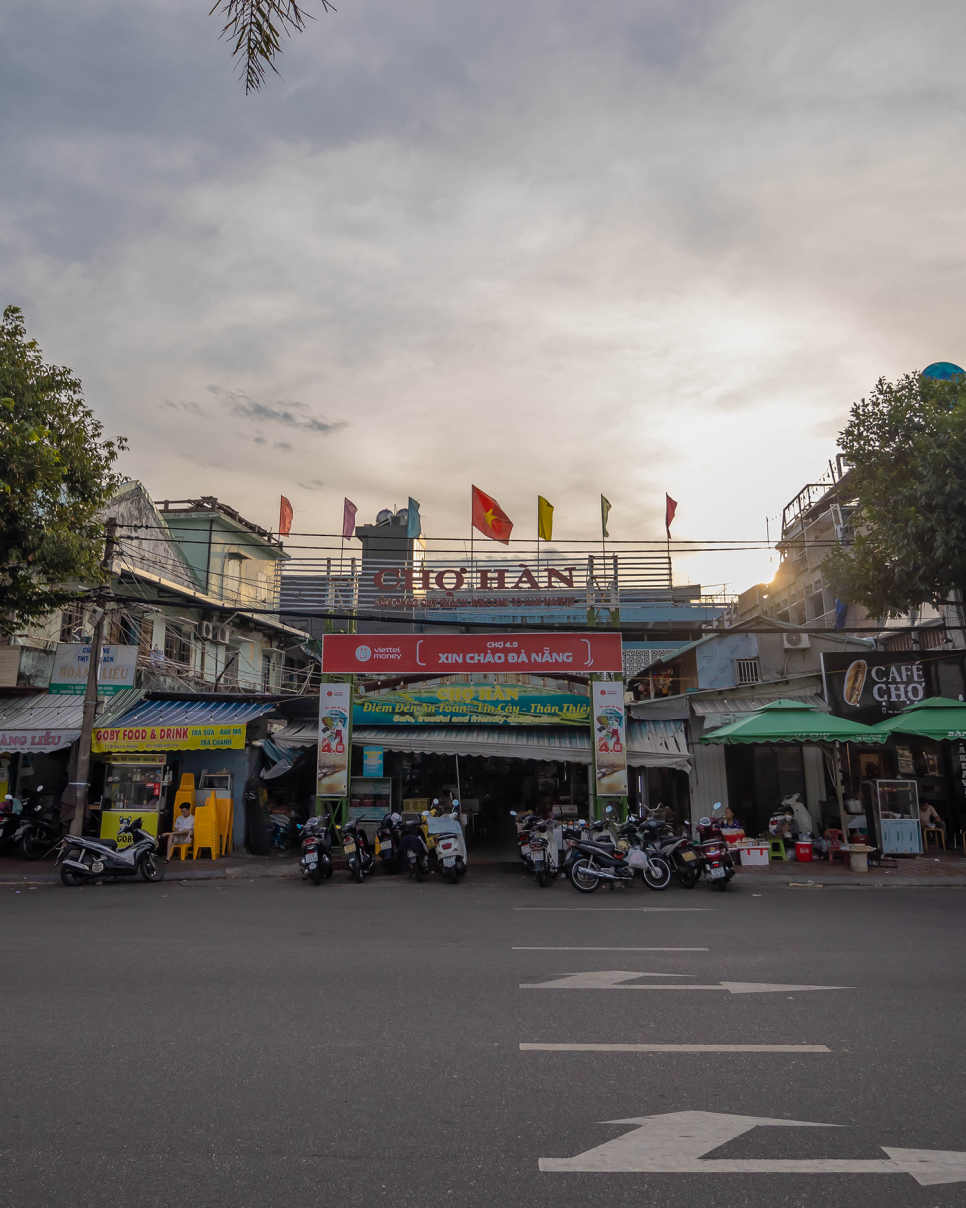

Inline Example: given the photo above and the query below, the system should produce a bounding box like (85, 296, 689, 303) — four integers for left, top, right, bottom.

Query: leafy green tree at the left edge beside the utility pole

(0, 306, 126, 635)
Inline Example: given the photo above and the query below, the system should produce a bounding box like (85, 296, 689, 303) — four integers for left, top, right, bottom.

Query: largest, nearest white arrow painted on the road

(540, 1111, 966, 1186)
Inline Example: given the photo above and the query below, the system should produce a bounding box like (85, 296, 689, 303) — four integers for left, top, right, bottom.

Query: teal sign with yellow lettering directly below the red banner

(353, 684, 590, 726)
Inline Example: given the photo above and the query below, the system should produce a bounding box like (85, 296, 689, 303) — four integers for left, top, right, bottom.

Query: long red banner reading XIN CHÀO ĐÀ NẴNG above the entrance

(322, 633, 623, 675)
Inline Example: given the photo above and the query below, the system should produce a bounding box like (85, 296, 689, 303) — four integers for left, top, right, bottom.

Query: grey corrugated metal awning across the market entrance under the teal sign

(273, 721, 691, 772)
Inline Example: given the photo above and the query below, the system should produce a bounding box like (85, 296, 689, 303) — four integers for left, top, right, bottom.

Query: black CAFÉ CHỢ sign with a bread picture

(822, 650, 962, 726)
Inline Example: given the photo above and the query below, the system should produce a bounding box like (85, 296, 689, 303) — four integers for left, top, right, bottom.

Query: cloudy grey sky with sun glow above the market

(0, 0, 966, 590)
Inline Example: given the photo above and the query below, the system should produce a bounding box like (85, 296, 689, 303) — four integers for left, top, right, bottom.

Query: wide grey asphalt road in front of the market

(0, 869, 966, 1208)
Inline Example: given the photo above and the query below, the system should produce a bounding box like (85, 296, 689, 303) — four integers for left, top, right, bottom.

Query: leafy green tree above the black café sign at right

(824, 373, 966, 617)
